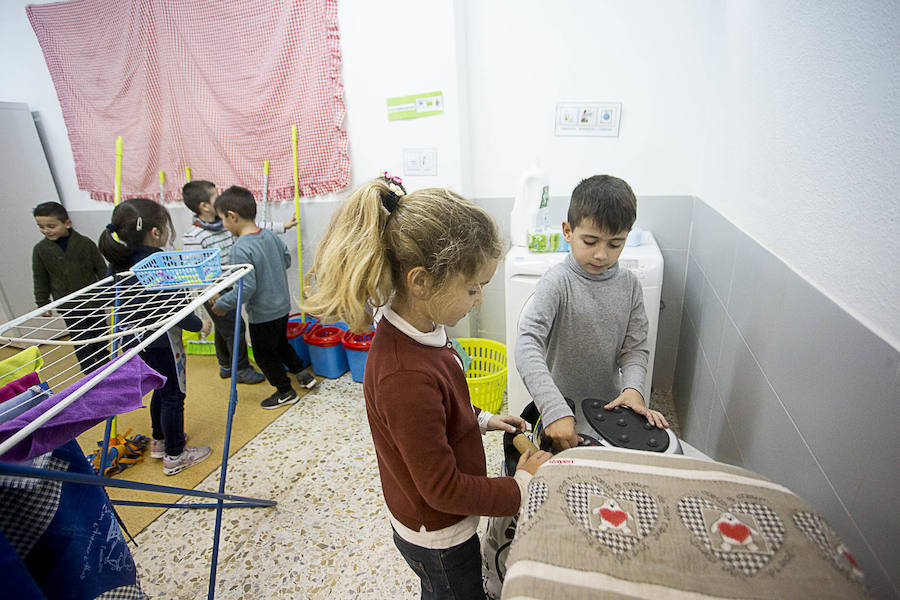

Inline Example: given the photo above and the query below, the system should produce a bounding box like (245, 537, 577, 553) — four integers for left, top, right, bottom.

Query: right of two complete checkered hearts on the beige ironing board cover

(678, 496, 785, 576)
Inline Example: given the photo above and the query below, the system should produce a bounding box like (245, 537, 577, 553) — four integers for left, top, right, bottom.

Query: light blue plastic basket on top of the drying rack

(131, 248, 222, 290)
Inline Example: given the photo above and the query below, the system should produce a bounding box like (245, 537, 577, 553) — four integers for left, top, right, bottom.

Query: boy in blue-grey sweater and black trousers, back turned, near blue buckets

(211, 186, 317, 408)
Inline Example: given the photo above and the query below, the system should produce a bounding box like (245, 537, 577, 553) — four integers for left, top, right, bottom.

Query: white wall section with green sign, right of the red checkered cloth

(339, 0, 462, 189)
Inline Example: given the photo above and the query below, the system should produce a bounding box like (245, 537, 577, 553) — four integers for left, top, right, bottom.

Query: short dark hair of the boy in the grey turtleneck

(567, 175, 637, 233)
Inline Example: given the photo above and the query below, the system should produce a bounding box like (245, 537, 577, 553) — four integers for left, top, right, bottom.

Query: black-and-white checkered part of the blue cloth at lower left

(0, 457, 69, 557)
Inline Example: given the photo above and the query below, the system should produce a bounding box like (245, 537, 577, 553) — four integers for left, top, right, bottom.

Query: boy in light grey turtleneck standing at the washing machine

(515, 175, 668, 450)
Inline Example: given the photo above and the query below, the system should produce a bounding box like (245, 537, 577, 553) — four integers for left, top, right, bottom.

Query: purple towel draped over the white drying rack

(0, 356, 166, 462)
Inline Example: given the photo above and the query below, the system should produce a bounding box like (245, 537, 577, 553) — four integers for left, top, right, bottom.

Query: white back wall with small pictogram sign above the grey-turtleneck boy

(466, 0, 712, 198)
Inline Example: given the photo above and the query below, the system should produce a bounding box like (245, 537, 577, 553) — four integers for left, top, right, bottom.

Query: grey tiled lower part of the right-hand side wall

(666, 199, 900, 598)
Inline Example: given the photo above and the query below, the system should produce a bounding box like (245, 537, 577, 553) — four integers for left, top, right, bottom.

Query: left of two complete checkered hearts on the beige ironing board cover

(565, 481, 659, 555)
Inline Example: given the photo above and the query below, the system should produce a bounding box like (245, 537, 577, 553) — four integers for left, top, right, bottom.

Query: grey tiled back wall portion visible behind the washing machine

(476, 196, 693, 390)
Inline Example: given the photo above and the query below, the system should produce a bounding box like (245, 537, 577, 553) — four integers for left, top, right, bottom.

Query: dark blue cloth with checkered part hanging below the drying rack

(0, 440, 143, 600)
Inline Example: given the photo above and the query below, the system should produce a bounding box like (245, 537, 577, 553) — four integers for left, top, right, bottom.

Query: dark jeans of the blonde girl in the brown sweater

(394, 531, 485, 600)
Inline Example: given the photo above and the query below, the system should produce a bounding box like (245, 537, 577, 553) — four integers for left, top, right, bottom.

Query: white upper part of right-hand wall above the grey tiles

(695, 0, 900, 348)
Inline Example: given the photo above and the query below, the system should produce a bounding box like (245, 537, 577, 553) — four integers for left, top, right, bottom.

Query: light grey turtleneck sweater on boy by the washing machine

(515, 254, 650, 425)
